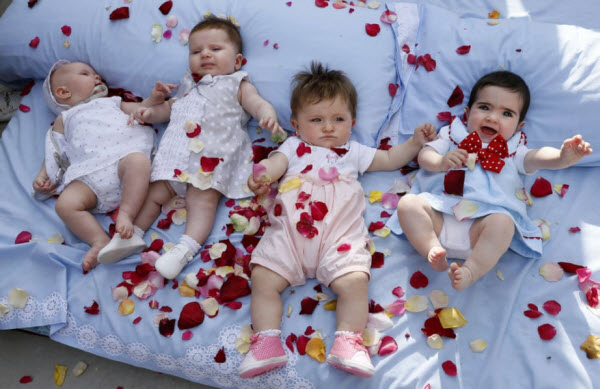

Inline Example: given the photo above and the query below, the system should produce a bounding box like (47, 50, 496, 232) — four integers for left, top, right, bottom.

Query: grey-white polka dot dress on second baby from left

(151, 71, 252, 198)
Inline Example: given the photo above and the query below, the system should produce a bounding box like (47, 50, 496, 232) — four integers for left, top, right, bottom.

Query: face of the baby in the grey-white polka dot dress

(189, 29, 243, 77)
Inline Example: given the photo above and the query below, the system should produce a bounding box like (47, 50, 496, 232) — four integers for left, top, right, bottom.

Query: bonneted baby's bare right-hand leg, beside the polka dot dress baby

(115, 153, 150, 239)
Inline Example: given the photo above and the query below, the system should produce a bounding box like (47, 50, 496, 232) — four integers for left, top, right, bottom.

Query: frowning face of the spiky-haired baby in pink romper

(291, 96, 356, 147)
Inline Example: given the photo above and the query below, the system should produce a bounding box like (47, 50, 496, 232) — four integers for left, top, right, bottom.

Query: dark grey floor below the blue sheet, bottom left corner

(0, 330, 216, 389)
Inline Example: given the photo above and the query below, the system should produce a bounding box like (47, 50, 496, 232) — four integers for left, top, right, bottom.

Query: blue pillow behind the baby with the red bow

(388, 3, 600, 166)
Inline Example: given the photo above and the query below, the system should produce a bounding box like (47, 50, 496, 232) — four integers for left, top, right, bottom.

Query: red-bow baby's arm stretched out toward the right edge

(523, 135, 592, 173)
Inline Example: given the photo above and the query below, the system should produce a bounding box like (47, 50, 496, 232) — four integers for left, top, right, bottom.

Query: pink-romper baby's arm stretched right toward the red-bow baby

(367, 123, 436, 171)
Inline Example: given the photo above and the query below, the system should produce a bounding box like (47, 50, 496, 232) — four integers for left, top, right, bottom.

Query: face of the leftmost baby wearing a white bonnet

(50, 62, 103, 106)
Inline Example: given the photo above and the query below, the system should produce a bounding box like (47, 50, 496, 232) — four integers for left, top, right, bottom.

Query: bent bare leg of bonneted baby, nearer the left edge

(55, 181, 110, 271)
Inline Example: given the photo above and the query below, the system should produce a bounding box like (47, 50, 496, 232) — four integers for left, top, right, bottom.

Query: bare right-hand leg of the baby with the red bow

(448, 213, 515, 290)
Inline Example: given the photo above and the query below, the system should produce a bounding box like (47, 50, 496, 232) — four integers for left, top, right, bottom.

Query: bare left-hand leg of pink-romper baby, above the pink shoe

(250, 265, 289, 332)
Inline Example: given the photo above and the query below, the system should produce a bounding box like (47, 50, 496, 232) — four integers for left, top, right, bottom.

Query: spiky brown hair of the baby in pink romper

(290, 61, 358, 119)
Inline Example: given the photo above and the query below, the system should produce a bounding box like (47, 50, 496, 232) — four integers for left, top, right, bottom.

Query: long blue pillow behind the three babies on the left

(0, 0, 404, 146)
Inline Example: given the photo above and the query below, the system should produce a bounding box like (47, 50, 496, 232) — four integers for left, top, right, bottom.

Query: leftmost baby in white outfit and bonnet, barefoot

(33, 60, 165, 271)
